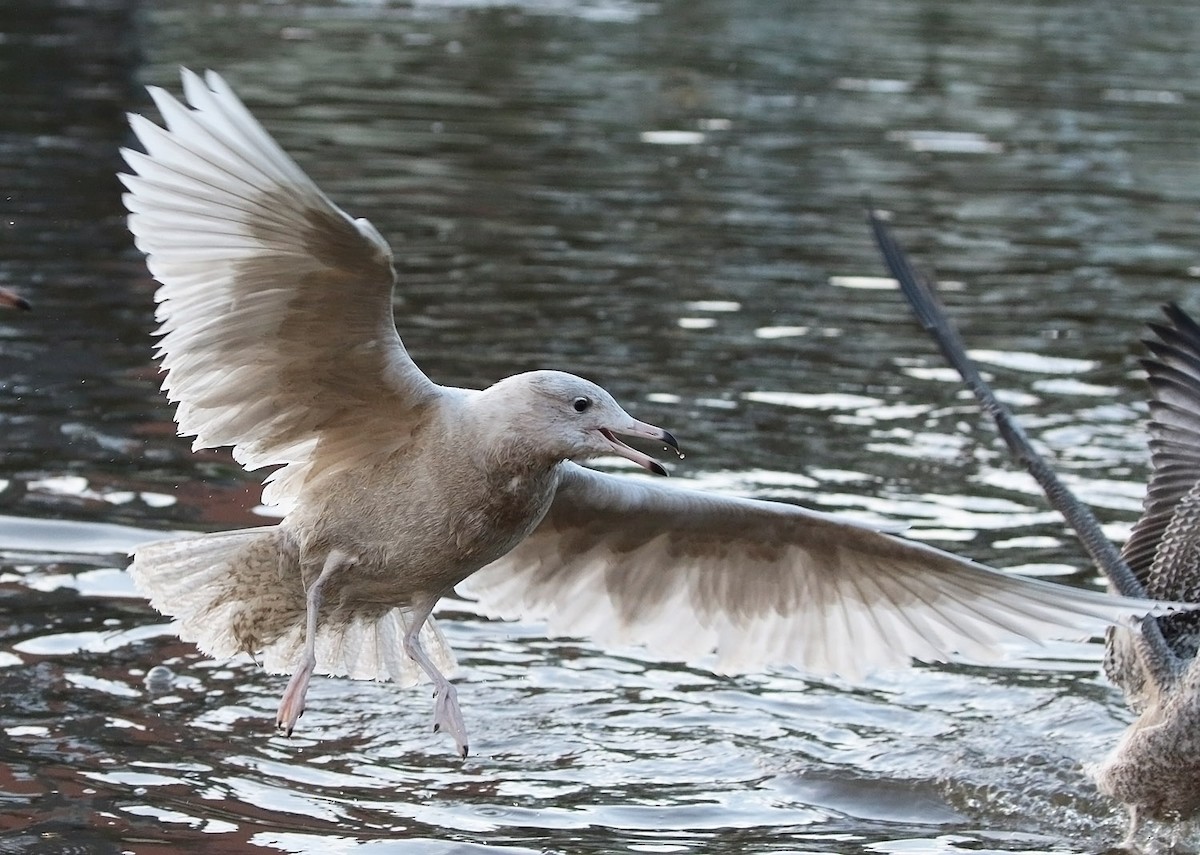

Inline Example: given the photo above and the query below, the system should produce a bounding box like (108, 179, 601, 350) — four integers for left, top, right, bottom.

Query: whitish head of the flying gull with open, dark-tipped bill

(484, 371, 679, 476)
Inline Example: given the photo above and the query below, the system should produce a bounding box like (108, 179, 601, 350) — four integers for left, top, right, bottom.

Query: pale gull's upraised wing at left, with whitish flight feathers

(120, 71, 438, 501)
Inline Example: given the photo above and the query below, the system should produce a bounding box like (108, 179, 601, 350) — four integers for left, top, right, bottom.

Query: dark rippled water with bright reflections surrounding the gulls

(7, 0, 1200, 854)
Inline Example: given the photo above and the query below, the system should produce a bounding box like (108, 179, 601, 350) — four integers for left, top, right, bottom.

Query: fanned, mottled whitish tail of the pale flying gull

(130, 526, 456, 686)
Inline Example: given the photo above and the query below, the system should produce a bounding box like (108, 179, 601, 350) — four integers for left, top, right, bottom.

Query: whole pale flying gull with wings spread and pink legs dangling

(121, 71, 1180, 755)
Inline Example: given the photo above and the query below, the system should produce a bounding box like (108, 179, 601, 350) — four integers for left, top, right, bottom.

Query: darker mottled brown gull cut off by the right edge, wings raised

(870, 211, 1200, 847)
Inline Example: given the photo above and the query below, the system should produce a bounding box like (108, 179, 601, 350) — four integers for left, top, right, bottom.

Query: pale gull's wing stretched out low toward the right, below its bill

(463, 465, 1153, 677)
